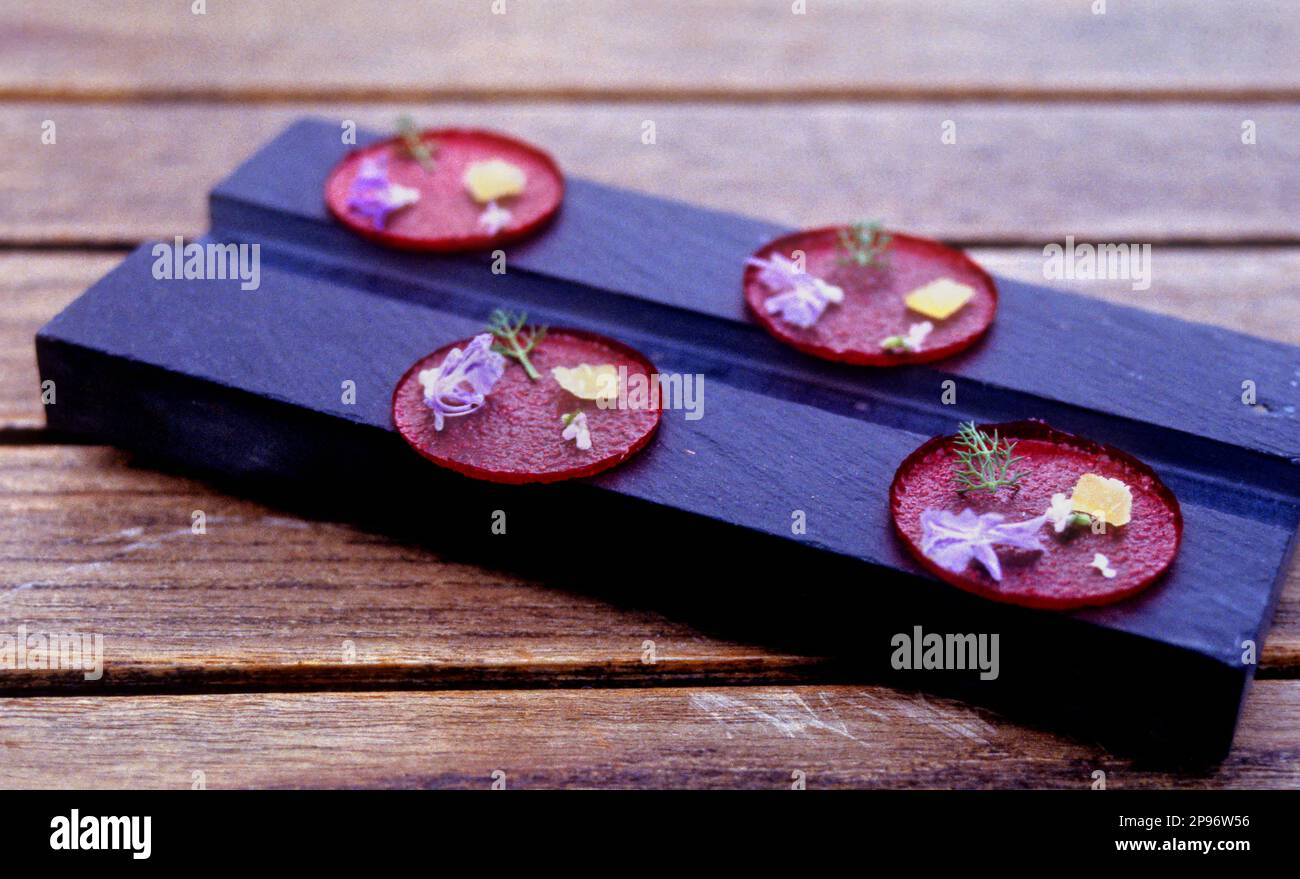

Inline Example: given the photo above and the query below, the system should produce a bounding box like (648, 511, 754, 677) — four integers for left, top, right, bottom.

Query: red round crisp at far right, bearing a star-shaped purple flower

(889, 421, 1183, 610)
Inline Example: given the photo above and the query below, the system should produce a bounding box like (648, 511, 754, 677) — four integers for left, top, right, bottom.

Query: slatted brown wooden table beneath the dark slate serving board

(0, 0, 1300, 788)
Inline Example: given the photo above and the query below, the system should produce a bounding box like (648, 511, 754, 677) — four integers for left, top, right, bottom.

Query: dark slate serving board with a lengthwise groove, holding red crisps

(36, 120, 1300, 758)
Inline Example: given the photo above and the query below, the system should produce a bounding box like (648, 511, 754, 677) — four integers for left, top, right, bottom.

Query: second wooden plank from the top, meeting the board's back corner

(0, 102, 1300, 243)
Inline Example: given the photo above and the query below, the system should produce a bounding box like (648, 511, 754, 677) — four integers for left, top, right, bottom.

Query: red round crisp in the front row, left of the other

(393, 329, 660, 484)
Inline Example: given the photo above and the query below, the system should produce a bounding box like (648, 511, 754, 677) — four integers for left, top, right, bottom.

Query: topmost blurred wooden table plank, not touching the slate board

(0, 0, 1300, 99)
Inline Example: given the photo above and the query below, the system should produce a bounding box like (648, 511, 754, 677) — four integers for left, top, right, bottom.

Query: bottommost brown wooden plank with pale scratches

(0, 681, 1300, 789)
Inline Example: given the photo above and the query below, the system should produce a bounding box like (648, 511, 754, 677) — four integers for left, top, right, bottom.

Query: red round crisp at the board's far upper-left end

(325, 129, 564, 252)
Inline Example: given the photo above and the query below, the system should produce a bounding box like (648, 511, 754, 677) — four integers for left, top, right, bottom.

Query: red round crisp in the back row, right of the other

(744, 226, 997, 367)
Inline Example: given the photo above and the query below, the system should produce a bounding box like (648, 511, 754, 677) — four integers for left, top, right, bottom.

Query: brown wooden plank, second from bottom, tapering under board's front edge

(0, 446, 811, 690)
